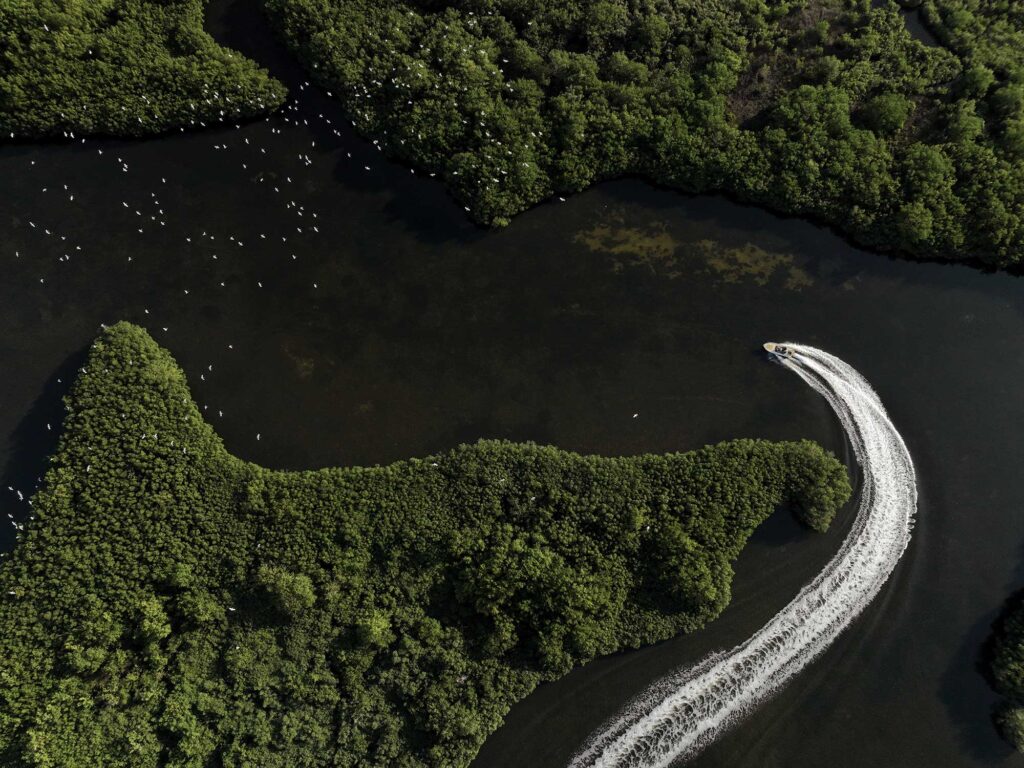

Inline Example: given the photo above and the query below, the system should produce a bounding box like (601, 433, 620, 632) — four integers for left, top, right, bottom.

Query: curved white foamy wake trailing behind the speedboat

(570, 342, 918, 768)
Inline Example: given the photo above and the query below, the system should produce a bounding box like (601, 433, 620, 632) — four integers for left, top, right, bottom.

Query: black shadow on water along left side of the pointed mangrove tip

(0, 346, 89, 552)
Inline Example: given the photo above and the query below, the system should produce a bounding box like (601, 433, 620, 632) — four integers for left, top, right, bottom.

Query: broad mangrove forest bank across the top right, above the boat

(266, 0, 1024, 266)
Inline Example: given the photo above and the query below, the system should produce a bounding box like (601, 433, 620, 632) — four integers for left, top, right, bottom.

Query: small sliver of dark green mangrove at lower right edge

(988, 594, 1024, 752)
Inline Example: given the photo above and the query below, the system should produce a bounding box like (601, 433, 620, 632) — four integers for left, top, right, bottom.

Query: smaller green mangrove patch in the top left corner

(0, 0, 286, 138)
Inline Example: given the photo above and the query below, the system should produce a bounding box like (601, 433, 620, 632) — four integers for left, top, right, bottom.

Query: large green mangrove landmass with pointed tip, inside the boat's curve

(0, 324, 850, 768)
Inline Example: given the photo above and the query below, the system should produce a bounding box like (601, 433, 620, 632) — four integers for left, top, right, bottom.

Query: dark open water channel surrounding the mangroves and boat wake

(0, 2, 1024, 768)
